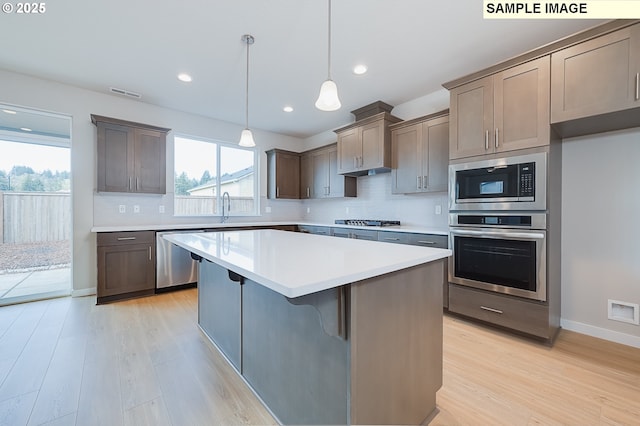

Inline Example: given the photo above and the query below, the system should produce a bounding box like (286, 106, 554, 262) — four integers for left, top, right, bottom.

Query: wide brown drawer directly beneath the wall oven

(449, 284, 552, 339)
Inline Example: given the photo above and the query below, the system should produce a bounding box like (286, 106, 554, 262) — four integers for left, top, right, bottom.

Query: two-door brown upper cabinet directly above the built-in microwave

(449, 56, 550, 159)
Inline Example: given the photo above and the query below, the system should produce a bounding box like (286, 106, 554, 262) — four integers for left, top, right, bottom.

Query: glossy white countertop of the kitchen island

(164, 229, 451, 297)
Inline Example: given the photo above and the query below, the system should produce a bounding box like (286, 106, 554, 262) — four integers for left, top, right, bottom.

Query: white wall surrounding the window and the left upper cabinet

(0, 70, 302, 295)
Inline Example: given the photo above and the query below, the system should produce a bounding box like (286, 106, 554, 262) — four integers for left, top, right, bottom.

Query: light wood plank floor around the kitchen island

(0, 289, 640, 426)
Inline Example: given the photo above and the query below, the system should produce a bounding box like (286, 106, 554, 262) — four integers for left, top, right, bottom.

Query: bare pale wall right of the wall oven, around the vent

(562, 129, 640, 347)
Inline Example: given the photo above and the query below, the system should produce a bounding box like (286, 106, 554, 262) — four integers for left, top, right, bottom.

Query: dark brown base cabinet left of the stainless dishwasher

(97, 231, 156, 304)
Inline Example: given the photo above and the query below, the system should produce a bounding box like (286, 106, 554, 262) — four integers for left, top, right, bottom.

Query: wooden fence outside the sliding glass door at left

(0, 192, 72, 243)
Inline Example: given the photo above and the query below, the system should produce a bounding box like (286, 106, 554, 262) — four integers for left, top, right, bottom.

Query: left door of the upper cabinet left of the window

(97, 123, 134, 192)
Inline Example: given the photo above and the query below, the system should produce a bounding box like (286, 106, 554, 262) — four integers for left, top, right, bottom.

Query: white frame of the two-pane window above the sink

(172, 132, 261, 218)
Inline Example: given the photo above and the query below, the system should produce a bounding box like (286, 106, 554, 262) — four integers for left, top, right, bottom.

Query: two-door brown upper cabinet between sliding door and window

(91, 114, 170, 194)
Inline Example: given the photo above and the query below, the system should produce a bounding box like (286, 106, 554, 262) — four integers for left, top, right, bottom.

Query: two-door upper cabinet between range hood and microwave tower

(391, 110, 449, 194)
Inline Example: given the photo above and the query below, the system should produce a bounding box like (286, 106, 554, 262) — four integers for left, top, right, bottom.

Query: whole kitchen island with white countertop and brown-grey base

(165, 230, 451, 424)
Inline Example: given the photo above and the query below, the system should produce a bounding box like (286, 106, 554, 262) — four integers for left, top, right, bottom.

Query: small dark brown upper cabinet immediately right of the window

(267, 149, 300, 199)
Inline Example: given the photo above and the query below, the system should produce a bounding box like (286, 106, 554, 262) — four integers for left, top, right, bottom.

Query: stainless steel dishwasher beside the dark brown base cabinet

(156, 230, 203, 292)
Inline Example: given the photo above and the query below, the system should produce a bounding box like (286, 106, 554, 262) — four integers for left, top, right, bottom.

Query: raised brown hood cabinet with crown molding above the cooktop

(335, 111, 401, 176)
